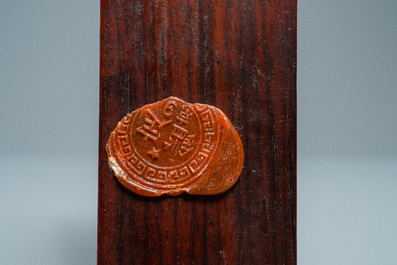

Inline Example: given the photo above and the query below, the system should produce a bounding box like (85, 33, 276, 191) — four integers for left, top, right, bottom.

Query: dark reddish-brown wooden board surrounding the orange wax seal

(97, 0, 297, 264)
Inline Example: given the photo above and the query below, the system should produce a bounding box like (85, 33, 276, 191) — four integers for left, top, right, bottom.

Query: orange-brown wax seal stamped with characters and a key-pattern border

(106, 97, 244, 196)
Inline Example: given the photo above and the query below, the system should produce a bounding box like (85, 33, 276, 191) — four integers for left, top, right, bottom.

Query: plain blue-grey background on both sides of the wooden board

(0, 0, 397, 265)
